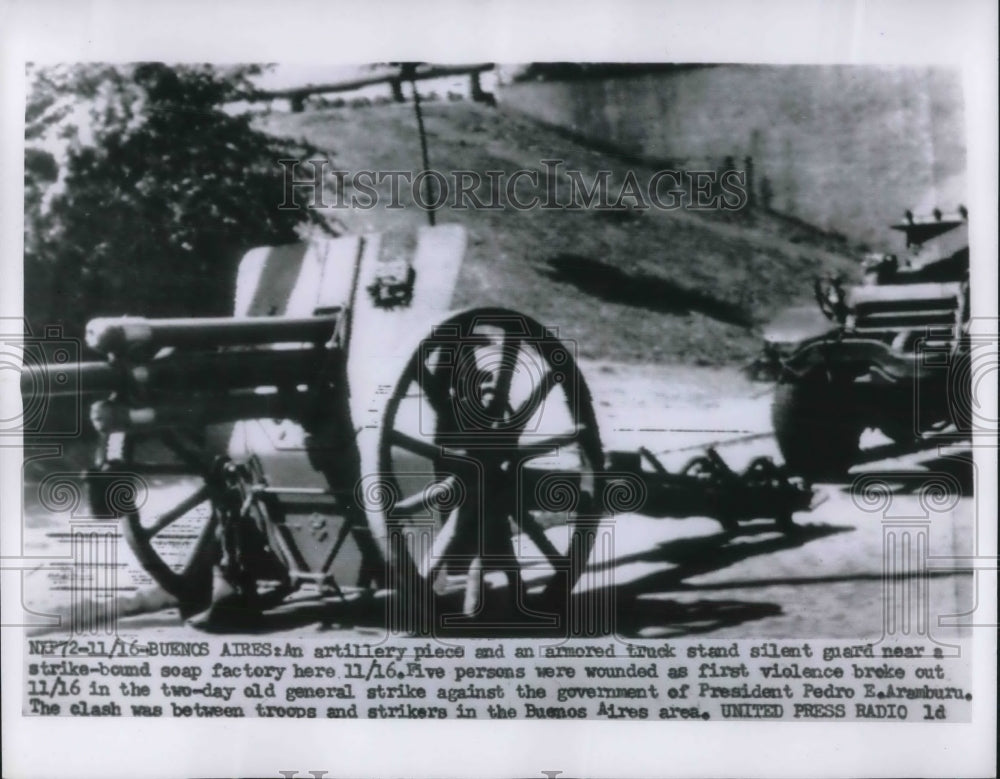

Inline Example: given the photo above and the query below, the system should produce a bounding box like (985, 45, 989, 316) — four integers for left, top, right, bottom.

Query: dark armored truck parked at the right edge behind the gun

(756, 207, 971, 480)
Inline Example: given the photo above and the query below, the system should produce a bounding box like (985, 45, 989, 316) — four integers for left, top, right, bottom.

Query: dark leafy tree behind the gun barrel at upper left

(24, 63, 329, 336)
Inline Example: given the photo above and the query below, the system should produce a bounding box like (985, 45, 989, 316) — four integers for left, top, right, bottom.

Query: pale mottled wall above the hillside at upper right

(498, 65, 965, 246)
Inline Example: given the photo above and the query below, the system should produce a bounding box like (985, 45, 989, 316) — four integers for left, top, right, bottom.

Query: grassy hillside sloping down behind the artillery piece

(260, 102, 855, 364)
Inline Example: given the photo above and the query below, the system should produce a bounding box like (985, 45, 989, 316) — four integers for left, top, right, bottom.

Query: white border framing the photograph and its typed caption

(0, 0, 997, 778)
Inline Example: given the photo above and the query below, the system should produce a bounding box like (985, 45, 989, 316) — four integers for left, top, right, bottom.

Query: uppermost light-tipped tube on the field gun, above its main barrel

(86, 312, 339, 354)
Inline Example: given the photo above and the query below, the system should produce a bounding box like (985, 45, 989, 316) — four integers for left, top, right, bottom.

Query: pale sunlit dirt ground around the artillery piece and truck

(11, 362, 976, 642)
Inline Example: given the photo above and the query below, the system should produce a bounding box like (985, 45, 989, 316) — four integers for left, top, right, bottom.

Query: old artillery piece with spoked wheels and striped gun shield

(22, 225, 811, 634)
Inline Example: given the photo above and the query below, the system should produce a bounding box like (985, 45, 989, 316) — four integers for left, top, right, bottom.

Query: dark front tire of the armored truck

(771, 377, 864, 481)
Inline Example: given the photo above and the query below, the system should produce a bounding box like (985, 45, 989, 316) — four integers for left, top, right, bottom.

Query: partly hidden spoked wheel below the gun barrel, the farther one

(89, 431, 230, 613)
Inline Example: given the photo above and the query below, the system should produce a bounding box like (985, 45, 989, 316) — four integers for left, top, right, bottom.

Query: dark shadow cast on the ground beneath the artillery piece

(35, 523, 847, 640)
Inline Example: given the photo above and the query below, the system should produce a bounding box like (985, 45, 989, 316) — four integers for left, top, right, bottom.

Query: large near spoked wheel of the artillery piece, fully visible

(378, 309, 603, 634)
